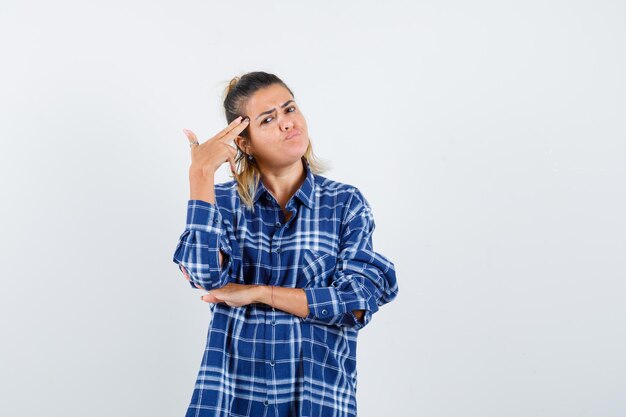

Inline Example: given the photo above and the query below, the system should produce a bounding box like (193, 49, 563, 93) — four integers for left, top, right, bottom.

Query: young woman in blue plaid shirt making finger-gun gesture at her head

(173, 72, 398, 417)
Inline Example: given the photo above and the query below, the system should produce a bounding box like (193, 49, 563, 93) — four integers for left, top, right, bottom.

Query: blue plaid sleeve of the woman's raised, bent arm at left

(172, 200, 240, 290)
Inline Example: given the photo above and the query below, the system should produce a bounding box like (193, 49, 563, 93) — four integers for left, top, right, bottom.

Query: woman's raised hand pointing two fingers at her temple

(183, 116, 250, 178)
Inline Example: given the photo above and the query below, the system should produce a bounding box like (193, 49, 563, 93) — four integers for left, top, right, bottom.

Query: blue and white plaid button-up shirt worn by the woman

(173, 160, 398, 417)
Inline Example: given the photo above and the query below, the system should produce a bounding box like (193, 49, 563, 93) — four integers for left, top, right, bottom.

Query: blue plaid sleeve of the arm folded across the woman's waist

(303, 190, 398, 330)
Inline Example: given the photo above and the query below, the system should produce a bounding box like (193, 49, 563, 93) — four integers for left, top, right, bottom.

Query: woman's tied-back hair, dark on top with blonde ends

(224, 71, 327, 211)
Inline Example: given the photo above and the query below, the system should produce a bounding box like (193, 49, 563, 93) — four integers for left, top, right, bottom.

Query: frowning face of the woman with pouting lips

(237, 84, 309, 167)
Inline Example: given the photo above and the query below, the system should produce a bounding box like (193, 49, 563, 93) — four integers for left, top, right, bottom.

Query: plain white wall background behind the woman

(0, 0, 626, 417)
